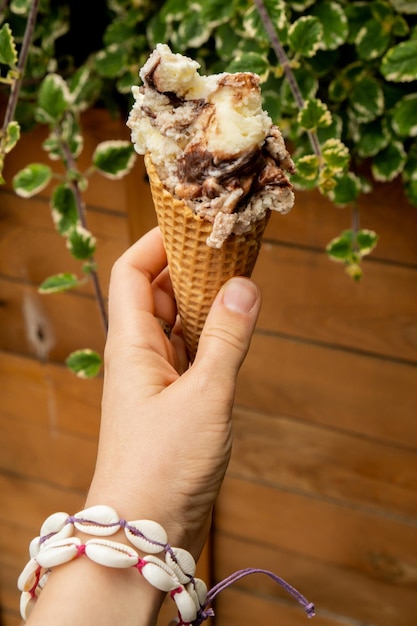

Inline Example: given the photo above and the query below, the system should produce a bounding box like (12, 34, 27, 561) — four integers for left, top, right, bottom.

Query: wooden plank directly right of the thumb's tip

(253, 244, 417, 363)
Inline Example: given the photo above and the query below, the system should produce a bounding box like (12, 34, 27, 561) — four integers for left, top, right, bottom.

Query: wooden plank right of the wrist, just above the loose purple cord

(215, 476, 417, 595)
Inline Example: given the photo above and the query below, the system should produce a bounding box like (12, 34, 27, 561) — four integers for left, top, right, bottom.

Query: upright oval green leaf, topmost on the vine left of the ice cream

(35, 74, 72, 124)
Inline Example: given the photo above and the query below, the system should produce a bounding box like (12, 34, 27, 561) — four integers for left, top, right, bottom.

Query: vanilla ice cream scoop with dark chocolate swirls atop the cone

(127, 44, 294, 248)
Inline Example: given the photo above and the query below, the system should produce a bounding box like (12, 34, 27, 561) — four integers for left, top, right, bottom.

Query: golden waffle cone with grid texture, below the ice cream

(145, 155, 270, 361)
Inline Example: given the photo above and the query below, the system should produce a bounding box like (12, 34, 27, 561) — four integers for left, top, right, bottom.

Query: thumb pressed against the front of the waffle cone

(194, 277, 261, 380)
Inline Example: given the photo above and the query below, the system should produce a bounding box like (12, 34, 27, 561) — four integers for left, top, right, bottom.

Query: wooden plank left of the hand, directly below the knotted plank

(0, 352, 103, 438)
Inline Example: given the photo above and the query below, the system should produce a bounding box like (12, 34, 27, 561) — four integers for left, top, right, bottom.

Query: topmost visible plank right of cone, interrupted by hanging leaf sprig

(265, 181, 417, 267)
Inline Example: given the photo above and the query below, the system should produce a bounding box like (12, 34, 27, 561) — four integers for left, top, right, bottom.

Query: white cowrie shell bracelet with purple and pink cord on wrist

(17, 505, 314, 626)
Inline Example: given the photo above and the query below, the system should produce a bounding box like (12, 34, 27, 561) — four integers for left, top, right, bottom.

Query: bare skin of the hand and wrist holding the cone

(27, 228, 261, 626)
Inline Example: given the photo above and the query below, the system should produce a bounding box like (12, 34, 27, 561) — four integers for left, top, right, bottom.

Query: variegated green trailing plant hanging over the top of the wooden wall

(0, 0, 417, 370)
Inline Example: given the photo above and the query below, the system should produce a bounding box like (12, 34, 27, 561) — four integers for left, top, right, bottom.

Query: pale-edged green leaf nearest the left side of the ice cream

(93, 140, 136, 179)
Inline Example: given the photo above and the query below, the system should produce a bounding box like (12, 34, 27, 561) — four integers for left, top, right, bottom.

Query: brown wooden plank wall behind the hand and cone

(0, 114, 417, 626)
